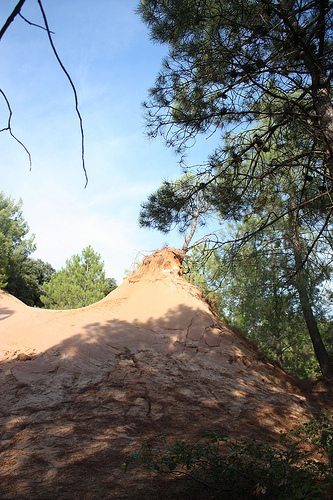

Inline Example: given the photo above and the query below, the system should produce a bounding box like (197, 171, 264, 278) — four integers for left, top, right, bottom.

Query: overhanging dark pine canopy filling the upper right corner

(138, 0, 333, 248)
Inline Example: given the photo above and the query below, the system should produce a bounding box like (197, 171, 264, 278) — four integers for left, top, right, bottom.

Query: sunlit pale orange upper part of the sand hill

(0, 247, 211, 357)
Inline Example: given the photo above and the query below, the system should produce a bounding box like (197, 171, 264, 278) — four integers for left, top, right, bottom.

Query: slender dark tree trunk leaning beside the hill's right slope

(290, 212, 333, 378)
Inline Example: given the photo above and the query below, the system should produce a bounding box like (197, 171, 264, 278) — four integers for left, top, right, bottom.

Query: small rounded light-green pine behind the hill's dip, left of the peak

(41, 245, 115, 309)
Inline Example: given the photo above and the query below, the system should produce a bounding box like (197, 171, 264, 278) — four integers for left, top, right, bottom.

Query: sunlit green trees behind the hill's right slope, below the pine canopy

(183, 245, 333, 378)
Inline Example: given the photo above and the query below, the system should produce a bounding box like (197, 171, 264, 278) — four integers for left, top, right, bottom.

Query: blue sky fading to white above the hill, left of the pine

(0, 0, 218, 284)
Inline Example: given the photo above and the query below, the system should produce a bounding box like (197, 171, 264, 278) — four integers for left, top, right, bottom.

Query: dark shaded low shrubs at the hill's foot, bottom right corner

(126, 410, 333, 500)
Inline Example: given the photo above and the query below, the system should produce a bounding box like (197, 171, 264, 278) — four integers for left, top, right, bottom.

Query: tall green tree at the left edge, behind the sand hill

(0, 191, 36, 293)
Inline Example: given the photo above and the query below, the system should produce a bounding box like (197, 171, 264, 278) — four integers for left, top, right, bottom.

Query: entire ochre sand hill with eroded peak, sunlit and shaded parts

(0, 248, 330, 500)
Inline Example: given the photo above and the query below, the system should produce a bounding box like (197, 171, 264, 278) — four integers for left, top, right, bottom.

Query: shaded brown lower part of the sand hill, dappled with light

(0, 306, 326, 500)
